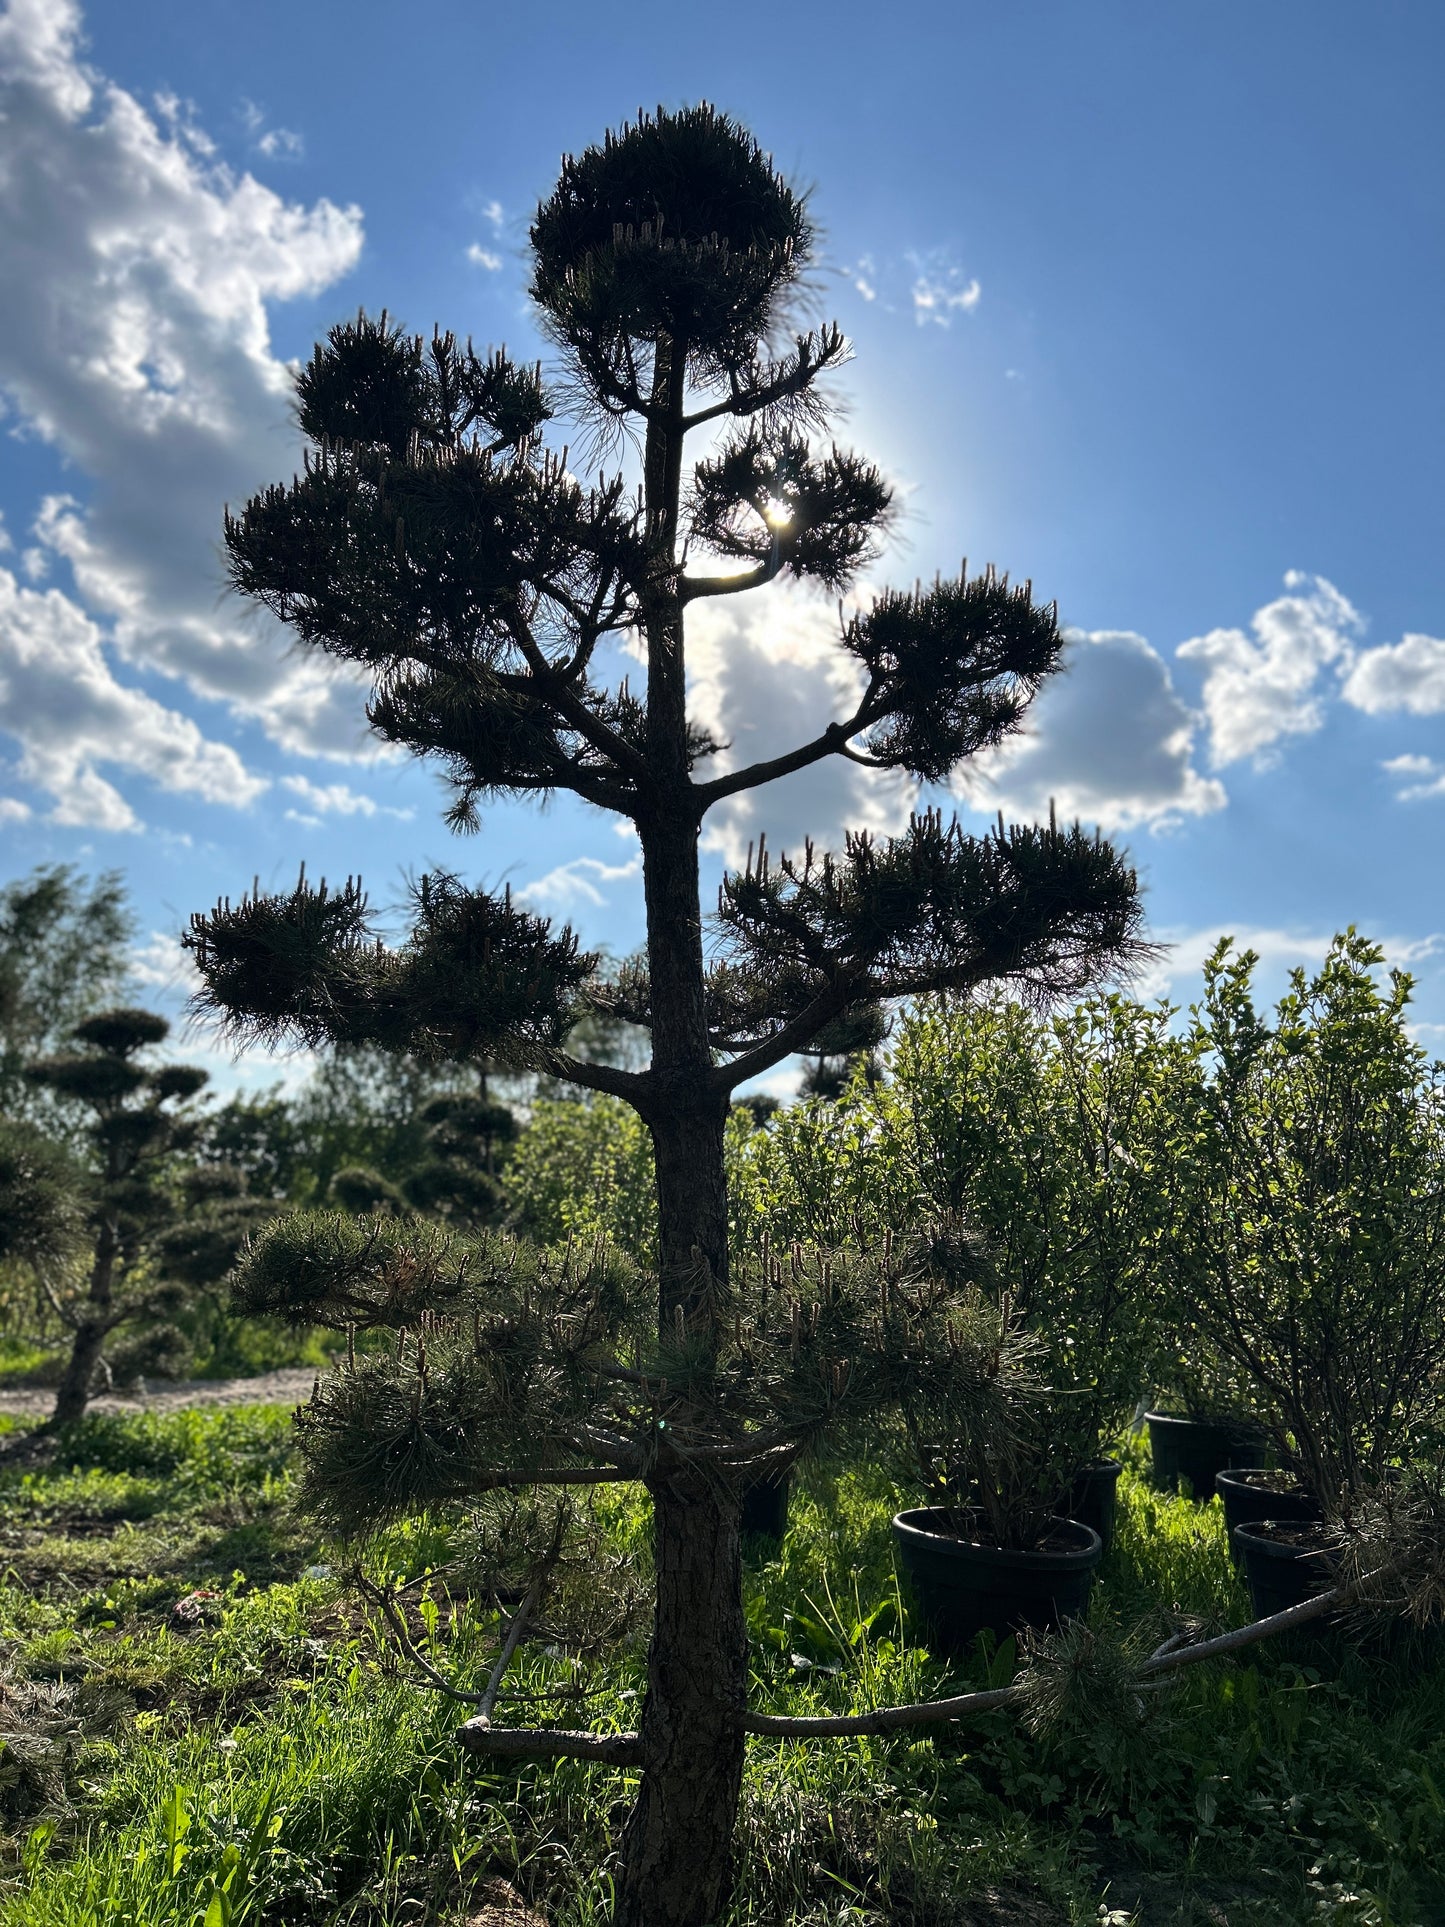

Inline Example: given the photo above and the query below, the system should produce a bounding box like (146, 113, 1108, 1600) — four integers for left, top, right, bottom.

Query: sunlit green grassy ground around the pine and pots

(0, 1407, 1445, 1927)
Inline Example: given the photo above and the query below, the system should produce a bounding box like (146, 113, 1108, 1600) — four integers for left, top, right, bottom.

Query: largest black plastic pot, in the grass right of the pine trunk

(894, 1505, 1104, 1653)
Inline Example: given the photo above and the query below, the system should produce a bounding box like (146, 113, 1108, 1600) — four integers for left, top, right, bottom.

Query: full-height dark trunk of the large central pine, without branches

(615, 323, 748, 1927)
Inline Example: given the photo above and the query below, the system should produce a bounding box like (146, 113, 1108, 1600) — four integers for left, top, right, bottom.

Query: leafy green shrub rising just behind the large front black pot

(882, 994, 1181, 1544)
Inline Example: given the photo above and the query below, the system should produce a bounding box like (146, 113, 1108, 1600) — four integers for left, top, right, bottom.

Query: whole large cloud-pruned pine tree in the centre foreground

(191, 106, 1139, 1927)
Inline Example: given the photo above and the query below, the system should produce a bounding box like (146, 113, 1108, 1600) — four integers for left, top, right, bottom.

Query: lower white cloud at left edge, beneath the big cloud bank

(0, 568, 266, 831)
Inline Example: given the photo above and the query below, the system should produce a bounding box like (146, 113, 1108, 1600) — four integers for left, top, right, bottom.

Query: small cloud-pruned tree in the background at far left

(25, 1008, 206, 1428)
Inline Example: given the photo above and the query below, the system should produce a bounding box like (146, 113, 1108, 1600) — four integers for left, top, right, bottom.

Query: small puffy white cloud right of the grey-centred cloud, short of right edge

(1175, 570, 1364, 769)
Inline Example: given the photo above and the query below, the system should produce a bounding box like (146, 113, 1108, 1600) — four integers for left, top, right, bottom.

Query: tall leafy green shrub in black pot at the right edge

(1168, 929, 1445, 1611)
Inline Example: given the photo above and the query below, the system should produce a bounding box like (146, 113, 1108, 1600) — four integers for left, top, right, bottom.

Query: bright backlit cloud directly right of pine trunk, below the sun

(688, 588, 917, 867)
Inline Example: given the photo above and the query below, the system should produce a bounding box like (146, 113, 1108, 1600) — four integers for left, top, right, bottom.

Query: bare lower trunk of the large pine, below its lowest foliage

(615, 1474, 748, 1927)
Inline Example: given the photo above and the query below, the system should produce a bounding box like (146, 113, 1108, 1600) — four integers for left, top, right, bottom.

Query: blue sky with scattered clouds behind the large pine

(0, 0, 1445, 1075)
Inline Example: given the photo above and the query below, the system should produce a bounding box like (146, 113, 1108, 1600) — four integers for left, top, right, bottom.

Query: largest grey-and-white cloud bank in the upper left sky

(0, 0, 379, 790)
